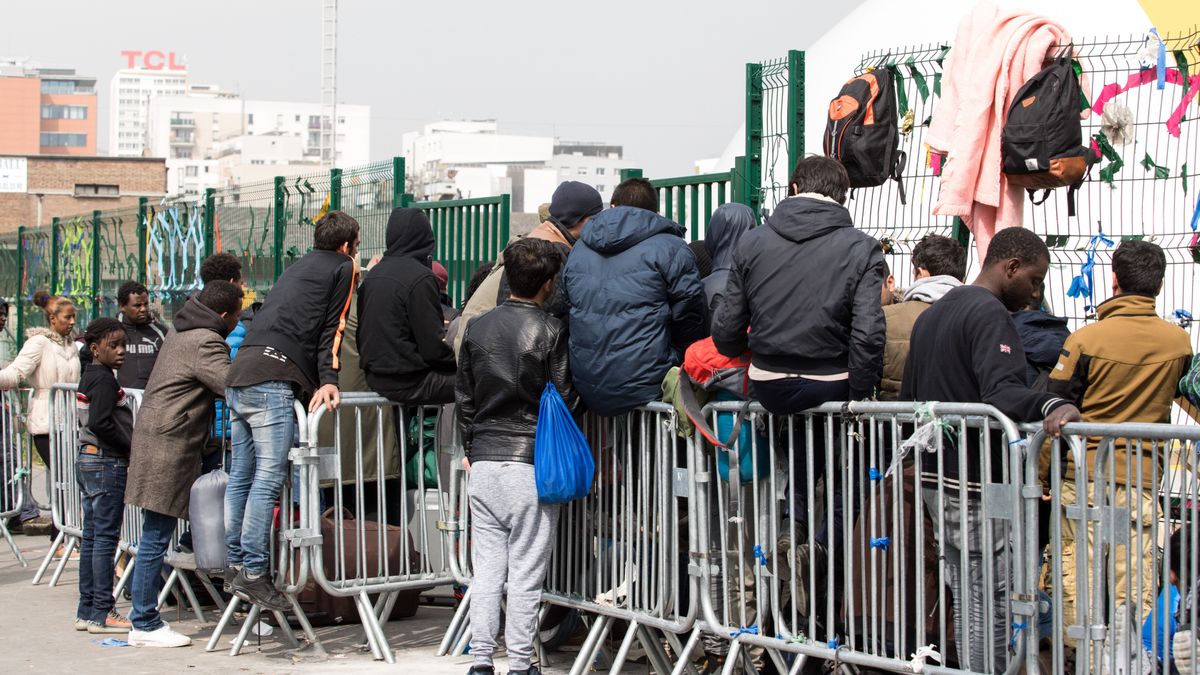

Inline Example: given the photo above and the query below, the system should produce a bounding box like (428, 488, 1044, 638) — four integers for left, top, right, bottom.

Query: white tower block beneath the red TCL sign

(108, 61, 188, 157)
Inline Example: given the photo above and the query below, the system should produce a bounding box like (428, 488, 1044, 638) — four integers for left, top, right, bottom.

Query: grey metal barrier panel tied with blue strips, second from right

(694, 402, 1032, 673)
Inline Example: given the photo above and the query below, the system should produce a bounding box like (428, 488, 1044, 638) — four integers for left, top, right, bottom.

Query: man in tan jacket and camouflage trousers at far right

(1050, 241, 1192, 641)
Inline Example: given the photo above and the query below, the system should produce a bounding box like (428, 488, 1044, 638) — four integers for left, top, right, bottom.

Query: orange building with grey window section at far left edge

(0, 59, 97, 155)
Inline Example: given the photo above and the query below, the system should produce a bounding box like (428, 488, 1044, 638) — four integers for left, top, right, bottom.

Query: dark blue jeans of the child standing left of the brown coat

(76, 453, 130, 623)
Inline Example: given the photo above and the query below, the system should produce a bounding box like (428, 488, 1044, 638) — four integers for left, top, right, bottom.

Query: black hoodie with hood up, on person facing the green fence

(358, 209, 455, 390)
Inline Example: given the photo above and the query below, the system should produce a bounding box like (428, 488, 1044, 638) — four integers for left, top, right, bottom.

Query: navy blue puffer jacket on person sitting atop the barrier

(563, 207, 707, 416)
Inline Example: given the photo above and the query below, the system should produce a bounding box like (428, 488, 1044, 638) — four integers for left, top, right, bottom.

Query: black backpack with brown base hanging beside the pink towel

(1000, 59, 1093, 216)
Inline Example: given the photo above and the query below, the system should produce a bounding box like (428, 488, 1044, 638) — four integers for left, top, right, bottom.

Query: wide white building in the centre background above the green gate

(403, 119, 630, 213)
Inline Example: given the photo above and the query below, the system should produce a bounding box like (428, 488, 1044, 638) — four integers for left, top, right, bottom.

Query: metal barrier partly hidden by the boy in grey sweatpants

(439, 404, 698, 674)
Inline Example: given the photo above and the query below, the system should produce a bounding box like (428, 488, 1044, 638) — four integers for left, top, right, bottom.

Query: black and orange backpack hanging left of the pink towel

(823, 68, 905, 204)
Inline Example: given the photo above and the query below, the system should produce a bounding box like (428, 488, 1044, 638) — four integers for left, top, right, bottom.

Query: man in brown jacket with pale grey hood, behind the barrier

(880, 234, 967, 401)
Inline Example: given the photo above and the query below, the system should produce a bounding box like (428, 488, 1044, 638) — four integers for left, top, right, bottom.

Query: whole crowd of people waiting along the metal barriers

(0, 156, 1195, 675)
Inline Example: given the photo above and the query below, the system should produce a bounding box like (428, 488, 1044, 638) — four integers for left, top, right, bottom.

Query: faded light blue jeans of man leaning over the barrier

(226, 382, 299, 577)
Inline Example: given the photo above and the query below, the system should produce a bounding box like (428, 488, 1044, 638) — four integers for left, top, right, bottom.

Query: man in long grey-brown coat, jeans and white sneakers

(125, 281, 242, 647)
